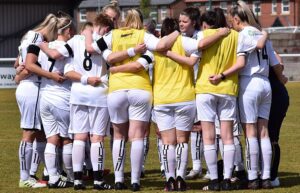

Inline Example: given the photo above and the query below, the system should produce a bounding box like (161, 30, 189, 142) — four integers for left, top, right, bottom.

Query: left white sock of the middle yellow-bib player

(162, 145, 176, 181)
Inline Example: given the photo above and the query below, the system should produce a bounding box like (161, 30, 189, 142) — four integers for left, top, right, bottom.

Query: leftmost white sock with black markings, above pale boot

(19, 141, 32, 181)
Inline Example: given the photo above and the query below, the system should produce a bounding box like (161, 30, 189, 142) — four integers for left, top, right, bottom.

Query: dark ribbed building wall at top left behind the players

(0, 0, 79, 58)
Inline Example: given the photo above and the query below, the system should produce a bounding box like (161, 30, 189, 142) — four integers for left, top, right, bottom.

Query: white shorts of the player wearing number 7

(40, 97, 72, 138)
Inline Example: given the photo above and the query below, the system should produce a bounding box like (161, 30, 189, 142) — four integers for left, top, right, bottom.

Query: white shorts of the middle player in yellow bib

(153, 103, 196, 131)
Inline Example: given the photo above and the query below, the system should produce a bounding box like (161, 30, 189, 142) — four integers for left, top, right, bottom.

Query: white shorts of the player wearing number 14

(239, 75, 272, 123)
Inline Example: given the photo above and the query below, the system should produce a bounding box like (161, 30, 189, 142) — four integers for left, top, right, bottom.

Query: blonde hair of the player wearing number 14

(230, 0, 262, 31)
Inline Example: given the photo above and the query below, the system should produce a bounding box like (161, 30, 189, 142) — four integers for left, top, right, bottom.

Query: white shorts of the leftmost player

(16, 81, 41, 130)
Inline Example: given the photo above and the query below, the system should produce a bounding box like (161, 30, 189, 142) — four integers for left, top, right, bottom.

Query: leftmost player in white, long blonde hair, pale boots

(16, 14, 58, 188)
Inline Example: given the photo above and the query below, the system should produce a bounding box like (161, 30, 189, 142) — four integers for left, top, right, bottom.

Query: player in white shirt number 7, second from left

(26, 16, 75, 188)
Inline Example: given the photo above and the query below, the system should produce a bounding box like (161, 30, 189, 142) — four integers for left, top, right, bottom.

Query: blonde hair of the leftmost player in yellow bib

(124, 9, 144, 29)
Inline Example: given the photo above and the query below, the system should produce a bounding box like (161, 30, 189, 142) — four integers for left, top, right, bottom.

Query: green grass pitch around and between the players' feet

(0, 82, 300, 193)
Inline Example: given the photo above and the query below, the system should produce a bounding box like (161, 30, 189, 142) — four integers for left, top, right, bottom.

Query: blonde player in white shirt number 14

(230, 1, 288, 189)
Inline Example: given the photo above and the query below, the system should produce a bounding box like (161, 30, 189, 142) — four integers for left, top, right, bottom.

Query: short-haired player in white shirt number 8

(60, 14, 113, 190)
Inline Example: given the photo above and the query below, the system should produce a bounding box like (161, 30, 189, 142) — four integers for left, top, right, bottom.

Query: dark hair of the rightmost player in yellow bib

(200, 8, 227, 29)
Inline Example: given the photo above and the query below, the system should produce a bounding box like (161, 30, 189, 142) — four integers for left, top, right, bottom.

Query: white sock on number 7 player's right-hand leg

(63, 143, 74, 181)
